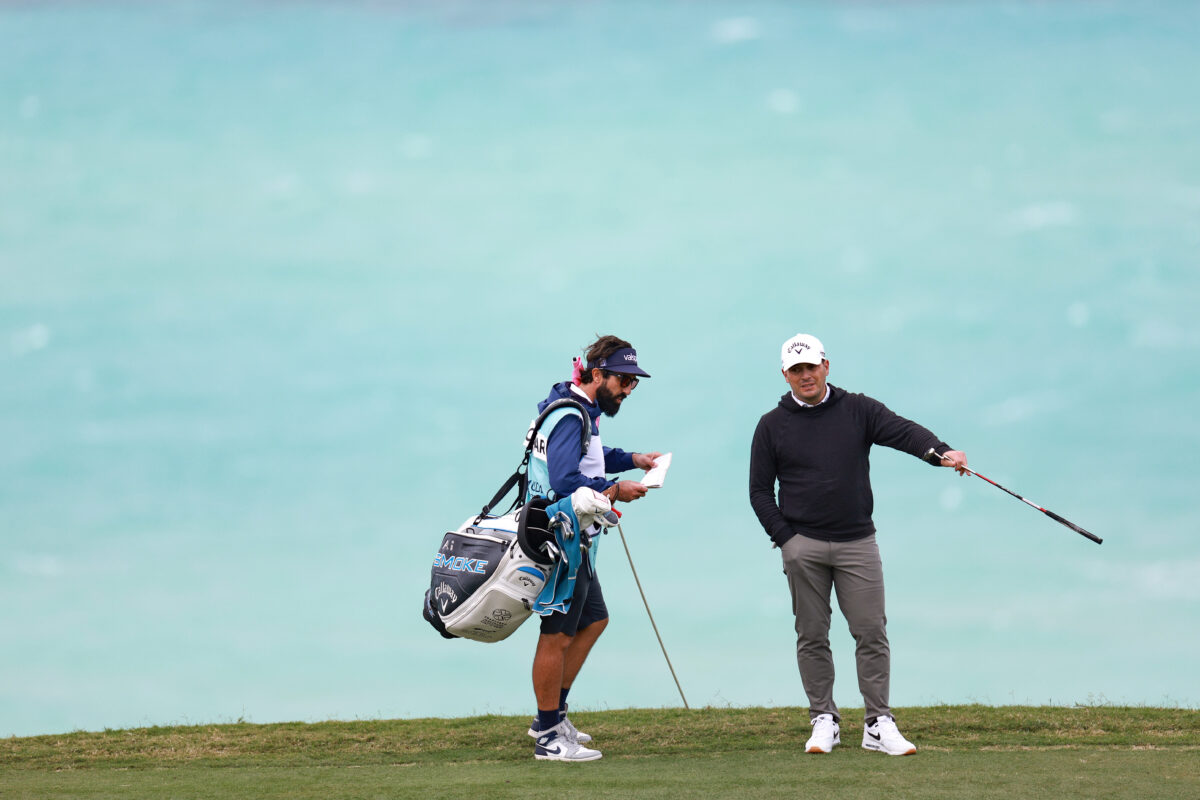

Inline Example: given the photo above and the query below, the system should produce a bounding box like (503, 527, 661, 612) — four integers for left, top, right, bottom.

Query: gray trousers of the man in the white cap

(782, 534, 892, 720)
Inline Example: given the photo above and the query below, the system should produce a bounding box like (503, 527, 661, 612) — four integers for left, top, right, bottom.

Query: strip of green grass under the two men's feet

(0, 705, 1200, 800)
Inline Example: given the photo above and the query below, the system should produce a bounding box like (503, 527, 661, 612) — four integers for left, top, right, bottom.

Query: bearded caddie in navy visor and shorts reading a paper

(528, 336, 661, 762)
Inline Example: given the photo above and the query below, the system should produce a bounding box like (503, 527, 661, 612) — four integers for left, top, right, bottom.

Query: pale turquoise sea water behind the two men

(0, 2, 1200, 735)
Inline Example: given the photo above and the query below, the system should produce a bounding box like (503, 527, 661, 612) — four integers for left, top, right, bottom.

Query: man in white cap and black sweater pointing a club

(750, 333, 967, 756)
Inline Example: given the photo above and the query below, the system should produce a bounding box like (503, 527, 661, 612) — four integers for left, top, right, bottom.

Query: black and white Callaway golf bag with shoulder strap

(422, 399, 592, 642)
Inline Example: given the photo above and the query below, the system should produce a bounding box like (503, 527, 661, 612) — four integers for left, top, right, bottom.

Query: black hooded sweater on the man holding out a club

(750, 385, 950, 546)
